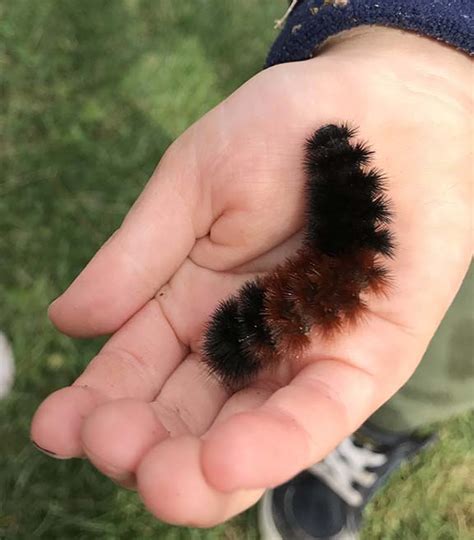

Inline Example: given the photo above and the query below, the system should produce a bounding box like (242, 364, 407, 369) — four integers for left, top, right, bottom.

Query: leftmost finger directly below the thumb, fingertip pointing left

(31, 300, 186, 457)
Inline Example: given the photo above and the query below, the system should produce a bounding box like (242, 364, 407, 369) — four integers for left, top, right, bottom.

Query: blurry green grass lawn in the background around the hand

(0, 0, 474, 540)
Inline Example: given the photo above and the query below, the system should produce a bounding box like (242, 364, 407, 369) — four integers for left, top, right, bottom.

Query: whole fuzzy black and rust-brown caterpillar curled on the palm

(203, 124, 394, 388)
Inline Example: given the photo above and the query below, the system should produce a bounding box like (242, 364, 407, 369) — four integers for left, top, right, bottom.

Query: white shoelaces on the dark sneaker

(308, 437, 387, 506)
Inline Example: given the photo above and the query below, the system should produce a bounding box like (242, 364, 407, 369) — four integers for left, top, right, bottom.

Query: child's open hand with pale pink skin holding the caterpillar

(31, 28, 473, 527)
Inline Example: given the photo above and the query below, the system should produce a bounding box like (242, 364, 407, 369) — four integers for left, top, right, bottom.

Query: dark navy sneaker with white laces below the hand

(259, 426, 435, 540)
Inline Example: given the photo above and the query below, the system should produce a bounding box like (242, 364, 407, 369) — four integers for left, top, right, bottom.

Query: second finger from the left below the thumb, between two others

(81, 354, 228, 485)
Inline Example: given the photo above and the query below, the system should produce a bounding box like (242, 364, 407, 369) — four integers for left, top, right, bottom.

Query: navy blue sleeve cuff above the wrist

(266, 0, 474, 67)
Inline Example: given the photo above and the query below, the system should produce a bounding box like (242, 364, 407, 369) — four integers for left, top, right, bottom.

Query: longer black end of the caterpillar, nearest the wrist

(305, 125, 393, 256)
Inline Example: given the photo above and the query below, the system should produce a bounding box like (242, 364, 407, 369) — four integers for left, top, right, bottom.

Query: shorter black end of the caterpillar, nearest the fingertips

(203, 281, 274, 387)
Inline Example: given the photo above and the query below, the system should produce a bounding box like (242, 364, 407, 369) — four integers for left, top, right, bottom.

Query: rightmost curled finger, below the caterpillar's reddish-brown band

(202, 323, 420, 492)
